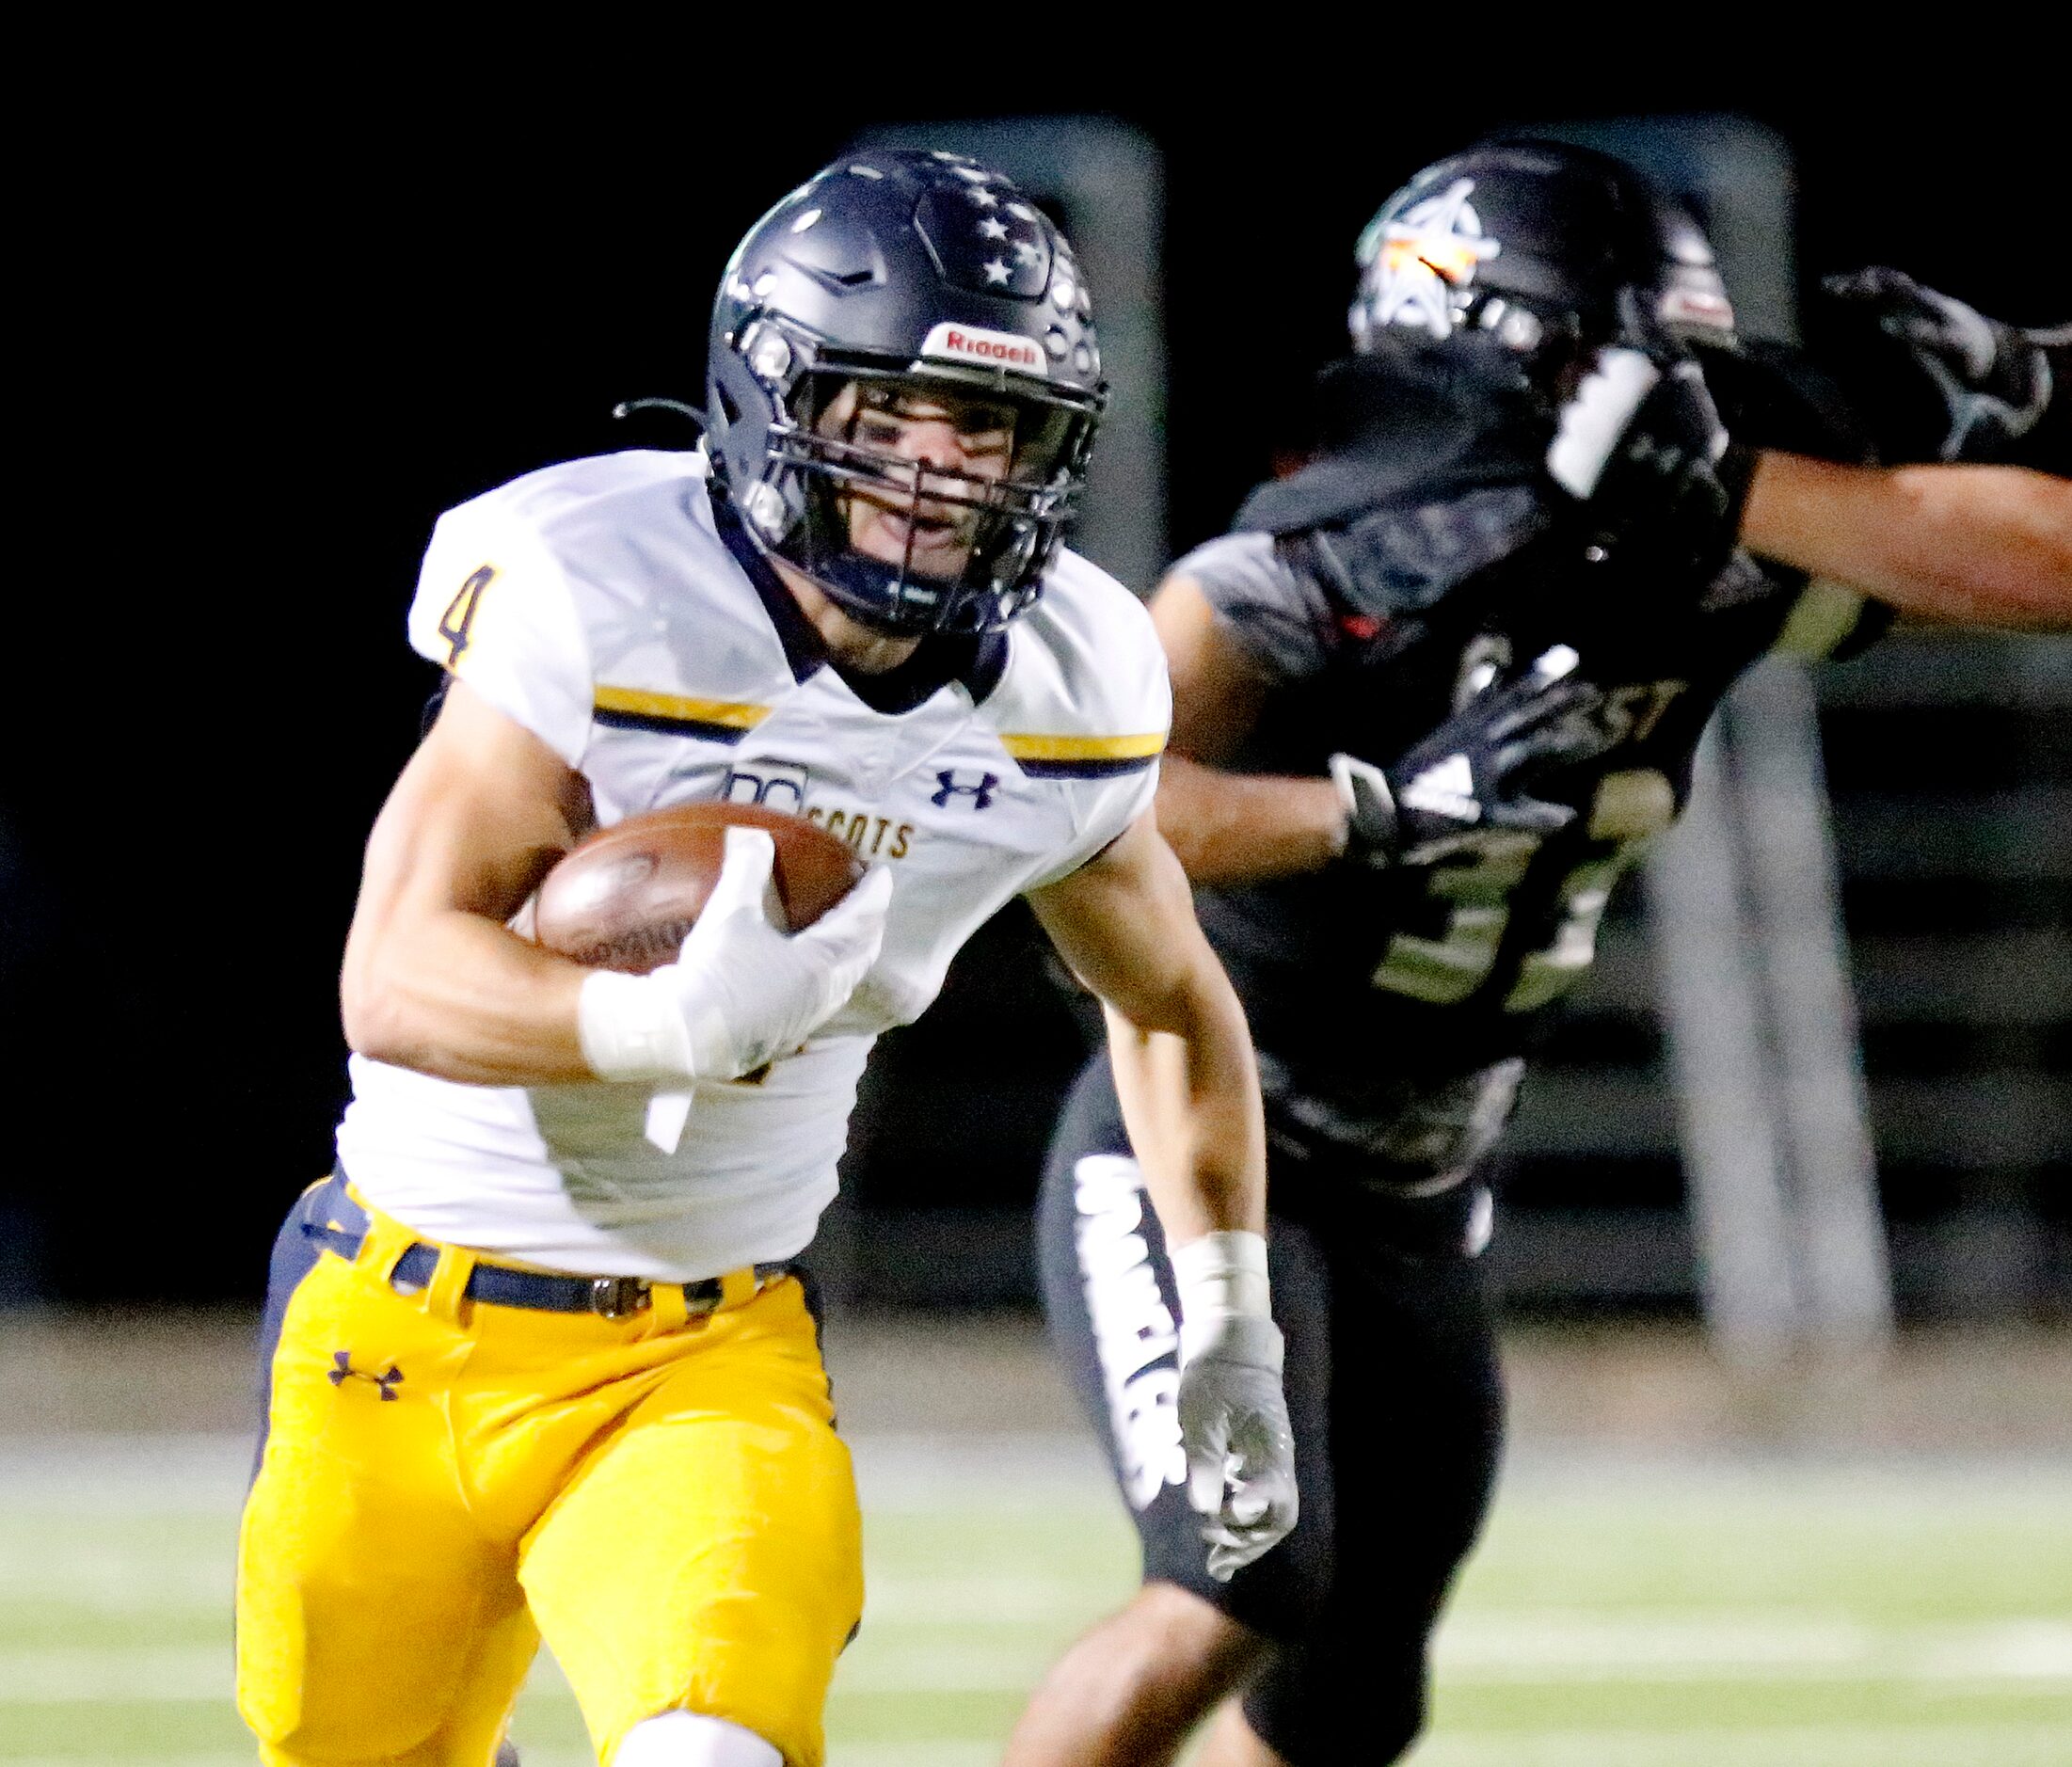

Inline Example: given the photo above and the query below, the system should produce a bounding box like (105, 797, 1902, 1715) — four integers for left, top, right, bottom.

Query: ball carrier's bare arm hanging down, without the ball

(1029, 816, 1266, 1243)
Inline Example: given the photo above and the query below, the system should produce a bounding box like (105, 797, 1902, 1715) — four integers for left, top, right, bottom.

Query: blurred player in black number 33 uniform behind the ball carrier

(1009, 143, 2072, 1767)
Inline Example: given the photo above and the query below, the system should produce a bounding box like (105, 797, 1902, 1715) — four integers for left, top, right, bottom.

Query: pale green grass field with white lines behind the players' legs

(0, 1438, 2072, 1767)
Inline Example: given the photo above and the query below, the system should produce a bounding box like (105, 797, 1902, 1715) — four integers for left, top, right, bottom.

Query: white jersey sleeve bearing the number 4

(410, 492, 595, 769)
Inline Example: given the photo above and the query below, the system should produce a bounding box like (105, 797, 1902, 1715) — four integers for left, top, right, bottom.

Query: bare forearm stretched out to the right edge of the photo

(1741, 450, 2072, 629)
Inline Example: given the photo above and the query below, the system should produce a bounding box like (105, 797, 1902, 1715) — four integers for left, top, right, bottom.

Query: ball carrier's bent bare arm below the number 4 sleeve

(340, 681, 595, 1086)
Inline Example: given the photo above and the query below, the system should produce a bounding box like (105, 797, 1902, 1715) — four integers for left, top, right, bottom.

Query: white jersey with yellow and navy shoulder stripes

(338, 452, 1171, 1282)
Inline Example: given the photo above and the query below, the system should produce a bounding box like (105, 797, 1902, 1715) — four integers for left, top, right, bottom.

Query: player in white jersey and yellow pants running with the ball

(238, 153, 1293, 1767)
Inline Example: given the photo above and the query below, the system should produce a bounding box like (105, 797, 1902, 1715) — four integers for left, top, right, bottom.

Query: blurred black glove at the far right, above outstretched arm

(1811, 267, 2072, 470)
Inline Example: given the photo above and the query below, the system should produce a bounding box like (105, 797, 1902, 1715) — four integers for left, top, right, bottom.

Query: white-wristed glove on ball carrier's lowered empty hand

(1172, 1233, 1297, 1583)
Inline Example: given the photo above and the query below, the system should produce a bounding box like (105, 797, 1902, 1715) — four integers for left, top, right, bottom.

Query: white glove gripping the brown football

(576, 829, 893, 1081)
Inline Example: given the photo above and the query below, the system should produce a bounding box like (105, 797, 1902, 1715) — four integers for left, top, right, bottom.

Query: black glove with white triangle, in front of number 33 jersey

(1331, 645, 1617, 866)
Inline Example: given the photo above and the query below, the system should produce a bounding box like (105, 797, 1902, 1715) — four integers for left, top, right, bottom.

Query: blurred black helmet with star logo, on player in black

(1349, 136, 1734, 379)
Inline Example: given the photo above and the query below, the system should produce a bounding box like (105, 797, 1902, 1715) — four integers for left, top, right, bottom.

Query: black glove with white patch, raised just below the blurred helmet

(1546, 290, 1741, 580)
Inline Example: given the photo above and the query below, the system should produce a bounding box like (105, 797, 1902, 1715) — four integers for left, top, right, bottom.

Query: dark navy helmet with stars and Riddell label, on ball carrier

(707, 151, 1107, 634)
